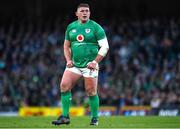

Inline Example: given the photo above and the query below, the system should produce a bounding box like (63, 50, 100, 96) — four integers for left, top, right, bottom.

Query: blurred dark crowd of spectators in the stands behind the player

(0, 17, 180, 110)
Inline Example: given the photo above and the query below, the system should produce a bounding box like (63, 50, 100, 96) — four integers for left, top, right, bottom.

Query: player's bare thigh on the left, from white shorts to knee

(60, 70, 81, 92)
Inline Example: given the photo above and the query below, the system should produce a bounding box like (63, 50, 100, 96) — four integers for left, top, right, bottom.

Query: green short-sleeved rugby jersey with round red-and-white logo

(65, 20, 106, 68)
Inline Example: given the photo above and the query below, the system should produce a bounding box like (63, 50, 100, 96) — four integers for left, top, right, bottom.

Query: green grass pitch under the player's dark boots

(0, 116, 180, 129)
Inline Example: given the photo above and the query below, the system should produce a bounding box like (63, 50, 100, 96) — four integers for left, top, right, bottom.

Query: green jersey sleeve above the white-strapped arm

(95, 23, 106, 40)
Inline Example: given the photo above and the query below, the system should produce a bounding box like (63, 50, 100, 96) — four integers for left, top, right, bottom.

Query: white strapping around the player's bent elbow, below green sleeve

(98, 38, 109, 56)
